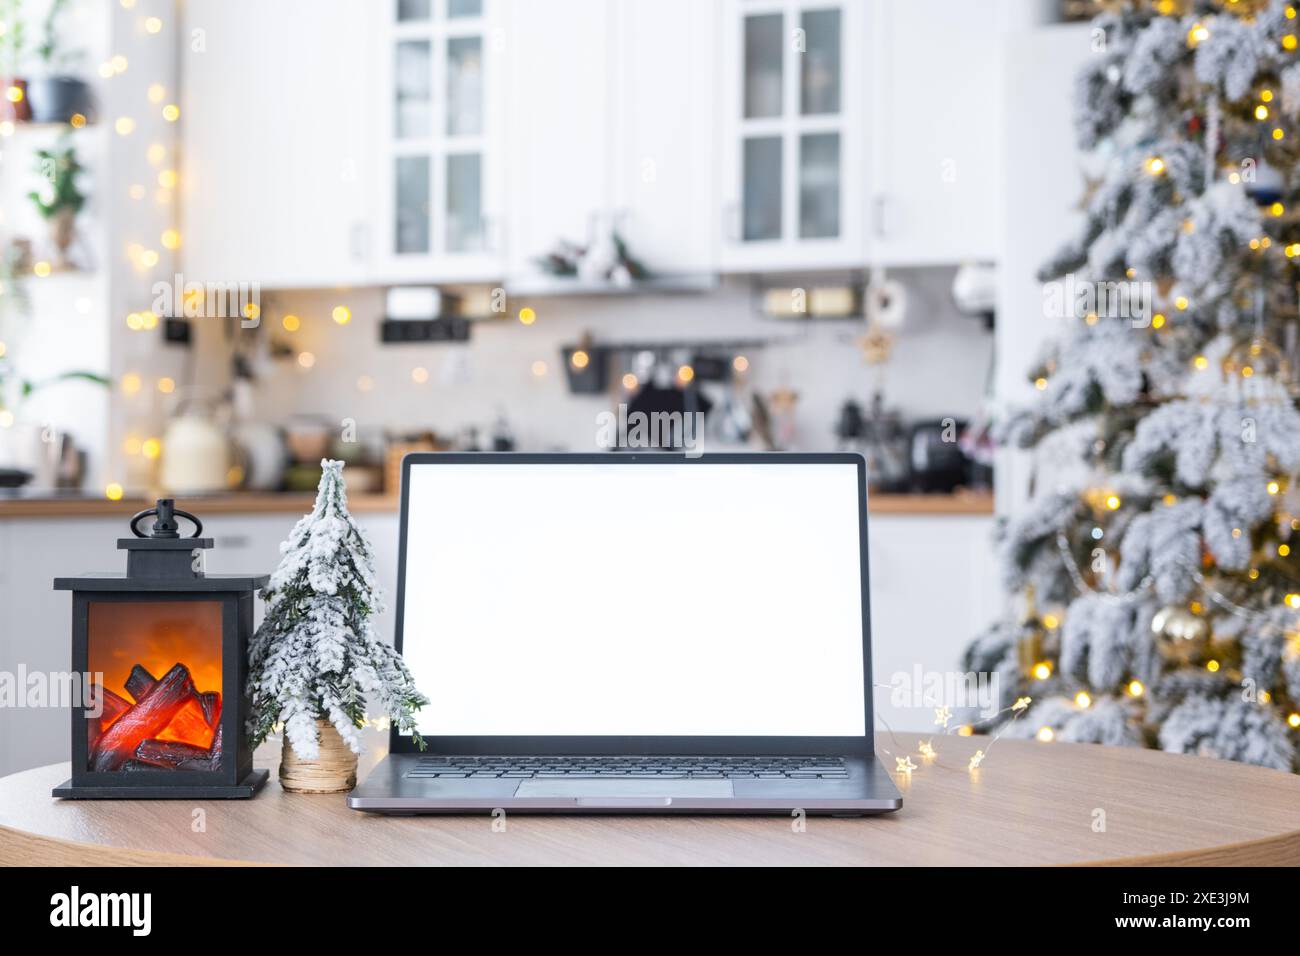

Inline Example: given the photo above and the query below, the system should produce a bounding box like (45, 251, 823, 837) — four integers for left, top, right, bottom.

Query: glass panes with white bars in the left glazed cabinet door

(385, 0, 494, 277)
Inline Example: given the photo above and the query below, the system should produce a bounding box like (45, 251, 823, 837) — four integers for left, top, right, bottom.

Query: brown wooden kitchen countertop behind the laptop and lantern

(0, 490, 993, 519)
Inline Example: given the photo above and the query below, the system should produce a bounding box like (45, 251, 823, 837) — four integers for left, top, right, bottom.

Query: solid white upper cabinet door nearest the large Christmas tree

(871, 0, 1004, 265)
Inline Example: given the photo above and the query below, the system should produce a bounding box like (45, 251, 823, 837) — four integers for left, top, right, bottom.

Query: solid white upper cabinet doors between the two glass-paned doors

(508, 0, 716, 286)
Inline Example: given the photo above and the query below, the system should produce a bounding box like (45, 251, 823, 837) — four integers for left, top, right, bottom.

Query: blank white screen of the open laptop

(402, 460, 866, 736)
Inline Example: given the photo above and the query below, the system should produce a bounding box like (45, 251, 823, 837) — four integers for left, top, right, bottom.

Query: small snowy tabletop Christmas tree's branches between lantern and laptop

(248, 460, 429, 767)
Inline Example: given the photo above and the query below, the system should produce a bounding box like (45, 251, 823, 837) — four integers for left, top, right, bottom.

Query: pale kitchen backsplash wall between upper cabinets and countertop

(160, 268, 993, 460)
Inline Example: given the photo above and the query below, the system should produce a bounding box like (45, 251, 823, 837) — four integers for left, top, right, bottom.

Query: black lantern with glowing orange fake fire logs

(55, 498, 268, 800)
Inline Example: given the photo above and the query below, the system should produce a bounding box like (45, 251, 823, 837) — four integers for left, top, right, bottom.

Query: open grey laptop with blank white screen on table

(348, 453, 902, 816)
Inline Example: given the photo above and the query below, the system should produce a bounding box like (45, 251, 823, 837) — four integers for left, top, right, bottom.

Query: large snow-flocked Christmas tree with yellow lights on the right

(966, 0, 1300, 770)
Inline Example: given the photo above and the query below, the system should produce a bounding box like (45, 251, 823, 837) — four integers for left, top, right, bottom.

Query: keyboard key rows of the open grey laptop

(407, 757, 849, 780)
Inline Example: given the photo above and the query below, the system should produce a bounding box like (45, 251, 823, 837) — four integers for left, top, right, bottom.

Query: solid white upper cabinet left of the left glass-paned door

(181, 0, 380, 287)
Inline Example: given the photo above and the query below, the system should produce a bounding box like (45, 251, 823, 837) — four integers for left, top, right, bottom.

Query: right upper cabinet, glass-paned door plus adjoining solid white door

(720, 0, 1013, 272)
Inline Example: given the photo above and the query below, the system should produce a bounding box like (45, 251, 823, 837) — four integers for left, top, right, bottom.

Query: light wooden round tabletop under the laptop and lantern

(0, 734, 1300, 865)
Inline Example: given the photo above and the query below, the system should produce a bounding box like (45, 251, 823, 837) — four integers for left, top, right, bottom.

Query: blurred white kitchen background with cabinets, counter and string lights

(0, 0, 1089, 774)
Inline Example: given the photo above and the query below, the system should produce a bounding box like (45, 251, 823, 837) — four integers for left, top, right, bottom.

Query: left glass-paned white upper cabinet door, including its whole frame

(373, 0, 507, 282)
